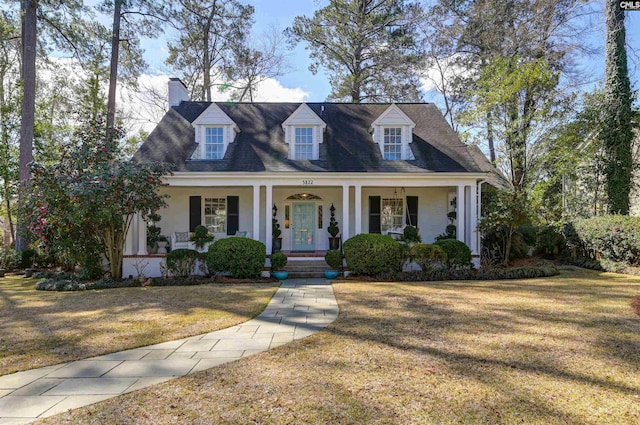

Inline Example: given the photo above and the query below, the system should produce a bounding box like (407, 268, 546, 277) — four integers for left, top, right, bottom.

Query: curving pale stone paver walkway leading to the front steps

(0, 279, 338, 425)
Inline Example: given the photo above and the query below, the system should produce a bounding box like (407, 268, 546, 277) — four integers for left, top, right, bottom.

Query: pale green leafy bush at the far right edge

(563, 215, 640, 266)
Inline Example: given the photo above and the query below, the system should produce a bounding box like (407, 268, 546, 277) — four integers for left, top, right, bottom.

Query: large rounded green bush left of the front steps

(206, 237, 267, 279)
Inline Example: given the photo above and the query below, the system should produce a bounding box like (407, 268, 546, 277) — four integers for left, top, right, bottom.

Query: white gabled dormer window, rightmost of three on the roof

(371, 104, 416, 161)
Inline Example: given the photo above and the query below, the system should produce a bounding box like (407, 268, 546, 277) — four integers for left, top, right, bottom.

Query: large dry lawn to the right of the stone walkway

(42, 269, 640, 424)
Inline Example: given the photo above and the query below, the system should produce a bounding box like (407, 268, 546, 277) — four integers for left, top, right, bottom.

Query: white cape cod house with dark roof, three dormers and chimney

(123, 79, 498, 276)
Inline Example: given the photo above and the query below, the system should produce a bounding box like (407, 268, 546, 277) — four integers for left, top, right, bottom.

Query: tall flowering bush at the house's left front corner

(23, 123, 170, 278)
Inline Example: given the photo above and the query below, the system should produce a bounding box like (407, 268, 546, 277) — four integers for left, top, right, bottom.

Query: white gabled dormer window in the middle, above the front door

(282, 103, 327, 161)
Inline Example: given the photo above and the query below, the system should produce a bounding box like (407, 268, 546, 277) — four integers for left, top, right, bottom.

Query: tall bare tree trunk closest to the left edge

(16, 0, 38, 252)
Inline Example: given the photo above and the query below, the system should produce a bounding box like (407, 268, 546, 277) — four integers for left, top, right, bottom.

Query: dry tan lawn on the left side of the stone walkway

(0, 276, 277, 375)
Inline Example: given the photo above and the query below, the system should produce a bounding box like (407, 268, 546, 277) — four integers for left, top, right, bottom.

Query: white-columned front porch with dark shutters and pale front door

(123, 173, 480, 276)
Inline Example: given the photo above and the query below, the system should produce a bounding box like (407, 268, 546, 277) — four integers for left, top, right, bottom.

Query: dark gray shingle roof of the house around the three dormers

(134, 102, 488, 173)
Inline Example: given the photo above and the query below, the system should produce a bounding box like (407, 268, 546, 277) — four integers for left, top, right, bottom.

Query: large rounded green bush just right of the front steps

(343, 234, 405, 276)
